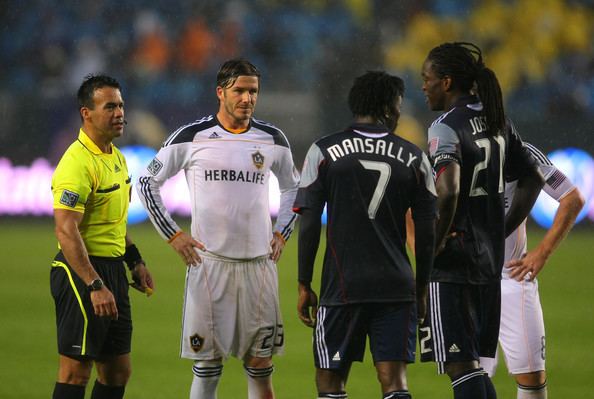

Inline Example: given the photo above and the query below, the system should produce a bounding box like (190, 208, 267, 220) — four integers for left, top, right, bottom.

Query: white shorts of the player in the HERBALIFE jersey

(181, 253, 284, 360)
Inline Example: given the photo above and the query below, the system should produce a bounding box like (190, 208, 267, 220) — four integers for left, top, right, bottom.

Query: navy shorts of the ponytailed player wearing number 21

(419, 282, 501, 372)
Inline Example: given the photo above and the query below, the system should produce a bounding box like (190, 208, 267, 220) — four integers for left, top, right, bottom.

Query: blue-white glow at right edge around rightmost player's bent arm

(530, 148, 594, 229)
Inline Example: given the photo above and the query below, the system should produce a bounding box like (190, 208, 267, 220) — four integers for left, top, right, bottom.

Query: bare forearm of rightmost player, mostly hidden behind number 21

(537, 188, 585, 259)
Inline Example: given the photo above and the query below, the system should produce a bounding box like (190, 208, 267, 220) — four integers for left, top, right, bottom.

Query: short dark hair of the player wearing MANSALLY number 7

(349, 71, 404, 120)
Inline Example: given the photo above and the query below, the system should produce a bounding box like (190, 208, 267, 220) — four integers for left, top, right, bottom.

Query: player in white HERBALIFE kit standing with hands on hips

(137, 59, 299, 399)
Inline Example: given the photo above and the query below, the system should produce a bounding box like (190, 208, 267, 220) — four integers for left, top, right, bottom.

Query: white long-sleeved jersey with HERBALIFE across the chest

(136, 115, 299, 259)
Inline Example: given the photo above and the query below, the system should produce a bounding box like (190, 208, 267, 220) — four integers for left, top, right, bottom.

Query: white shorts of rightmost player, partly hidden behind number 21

(481, 278, 545, 377)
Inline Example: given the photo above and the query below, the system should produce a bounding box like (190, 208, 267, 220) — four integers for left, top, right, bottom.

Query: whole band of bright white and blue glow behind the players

(0, 146, 594, 228)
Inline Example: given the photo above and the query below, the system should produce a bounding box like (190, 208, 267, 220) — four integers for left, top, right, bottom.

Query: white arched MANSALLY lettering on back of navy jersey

(328, 137, 417, 166)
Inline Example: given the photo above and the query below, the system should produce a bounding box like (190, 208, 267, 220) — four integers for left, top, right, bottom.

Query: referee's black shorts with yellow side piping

(50, 251, 132, 359)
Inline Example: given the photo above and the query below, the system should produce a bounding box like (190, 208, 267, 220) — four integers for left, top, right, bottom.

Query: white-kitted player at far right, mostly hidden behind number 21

(480, 143, 584, 399)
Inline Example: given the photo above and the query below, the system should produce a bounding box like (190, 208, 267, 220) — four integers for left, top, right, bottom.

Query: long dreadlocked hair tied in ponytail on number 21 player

(427, 42, 505, 135)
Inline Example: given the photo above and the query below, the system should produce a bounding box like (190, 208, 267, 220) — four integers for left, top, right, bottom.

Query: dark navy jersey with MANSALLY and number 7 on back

(294, 124, 436, 306)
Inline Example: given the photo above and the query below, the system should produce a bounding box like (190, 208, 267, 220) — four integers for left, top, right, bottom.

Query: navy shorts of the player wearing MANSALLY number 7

(313, 302, 417, 370)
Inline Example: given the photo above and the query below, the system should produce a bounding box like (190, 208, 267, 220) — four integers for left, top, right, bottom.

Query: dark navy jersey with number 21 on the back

(429, 96, 536, 284)
